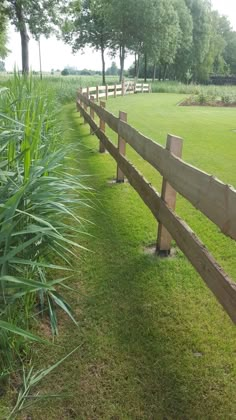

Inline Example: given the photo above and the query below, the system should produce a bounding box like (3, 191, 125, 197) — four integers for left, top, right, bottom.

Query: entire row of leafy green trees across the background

(0, 0, 236, 83)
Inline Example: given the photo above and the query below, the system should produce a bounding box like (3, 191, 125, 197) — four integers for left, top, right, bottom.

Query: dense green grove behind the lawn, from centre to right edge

(62, 0, 236, 83)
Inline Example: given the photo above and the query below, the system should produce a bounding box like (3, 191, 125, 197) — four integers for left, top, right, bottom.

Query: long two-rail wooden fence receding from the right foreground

(77, 92, 236, 323)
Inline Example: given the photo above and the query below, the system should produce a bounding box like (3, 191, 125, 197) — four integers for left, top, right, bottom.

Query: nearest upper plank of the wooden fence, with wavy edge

(118, 121, 236, 239)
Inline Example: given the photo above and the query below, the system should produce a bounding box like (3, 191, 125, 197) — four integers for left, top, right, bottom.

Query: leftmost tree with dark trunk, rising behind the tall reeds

(0, 0, 65, 75)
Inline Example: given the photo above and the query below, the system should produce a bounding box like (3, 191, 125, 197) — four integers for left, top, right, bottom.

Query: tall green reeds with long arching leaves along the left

(0, 73, 88, 379)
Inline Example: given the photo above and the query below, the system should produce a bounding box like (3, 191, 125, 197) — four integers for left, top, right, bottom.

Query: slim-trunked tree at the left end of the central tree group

(62, 0, 111, 84)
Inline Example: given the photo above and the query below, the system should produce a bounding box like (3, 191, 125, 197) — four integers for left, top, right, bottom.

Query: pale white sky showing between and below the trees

(5, 0, 236, 71)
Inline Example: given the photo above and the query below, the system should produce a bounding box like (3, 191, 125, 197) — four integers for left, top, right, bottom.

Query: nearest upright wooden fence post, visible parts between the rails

(156, 134, 183, 257)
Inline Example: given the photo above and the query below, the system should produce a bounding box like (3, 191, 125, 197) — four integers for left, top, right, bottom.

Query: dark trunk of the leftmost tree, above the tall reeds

(15, 2, 29, 76)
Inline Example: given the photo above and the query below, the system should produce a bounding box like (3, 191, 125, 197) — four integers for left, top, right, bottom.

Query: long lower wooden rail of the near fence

(79, 101, 236, 323)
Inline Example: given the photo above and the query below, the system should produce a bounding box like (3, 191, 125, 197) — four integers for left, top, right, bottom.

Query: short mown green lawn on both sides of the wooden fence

(16, 94, 236, 420)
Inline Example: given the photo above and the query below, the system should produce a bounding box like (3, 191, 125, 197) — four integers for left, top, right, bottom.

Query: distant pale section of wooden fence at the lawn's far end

(80, 81, 151, 102)
